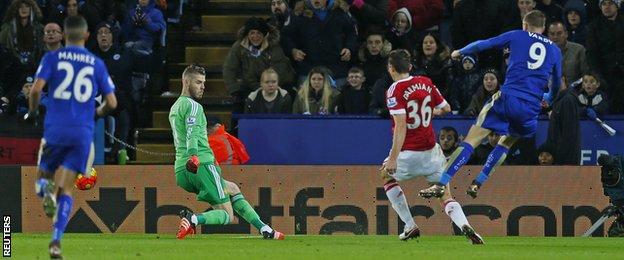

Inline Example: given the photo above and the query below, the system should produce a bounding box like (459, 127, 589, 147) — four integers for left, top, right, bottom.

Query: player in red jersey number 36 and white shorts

(381, 50, 483, 244)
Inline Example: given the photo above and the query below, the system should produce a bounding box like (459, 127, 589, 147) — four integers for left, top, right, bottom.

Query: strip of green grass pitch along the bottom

(12, 234, 624, 260)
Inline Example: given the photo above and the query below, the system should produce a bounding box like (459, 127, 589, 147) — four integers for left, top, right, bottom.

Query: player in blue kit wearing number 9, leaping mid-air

(420, 10, 562, 198)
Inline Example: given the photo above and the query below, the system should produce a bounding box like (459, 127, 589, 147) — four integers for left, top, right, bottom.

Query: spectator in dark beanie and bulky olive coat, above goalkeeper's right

(223, 17, 295, 109)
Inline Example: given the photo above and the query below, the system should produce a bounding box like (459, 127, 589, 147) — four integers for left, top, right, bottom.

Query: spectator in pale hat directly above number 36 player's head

(386, 8, 416, 50)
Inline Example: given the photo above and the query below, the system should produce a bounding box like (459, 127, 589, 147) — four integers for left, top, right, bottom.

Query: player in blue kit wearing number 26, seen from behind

(24, 16, 117, 259)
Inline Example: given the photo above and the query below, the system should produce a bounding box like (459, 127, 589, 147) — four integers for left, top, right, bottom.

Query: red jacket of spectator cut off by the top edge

(388, 0, 444, 35)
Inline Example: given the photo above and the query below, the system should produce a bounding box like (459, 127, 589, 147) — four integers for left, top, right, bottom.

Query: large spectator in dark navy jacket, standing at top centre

(284, 0, 358, 86)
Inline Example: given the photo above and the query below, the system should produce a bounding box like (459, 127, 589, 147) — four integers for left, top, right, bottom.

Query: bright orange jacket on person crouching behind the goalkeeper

(206, 118, 249, 165)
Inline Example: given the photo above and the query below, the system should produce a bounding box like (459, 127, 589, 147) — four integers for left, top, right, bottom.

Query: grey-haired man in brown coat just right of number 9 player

(548, 21, 589, 82)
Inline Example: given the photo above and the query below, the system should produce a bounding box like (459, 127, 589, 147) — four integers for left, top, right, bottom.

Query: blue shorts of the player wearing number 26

(39, 139, 95, 173)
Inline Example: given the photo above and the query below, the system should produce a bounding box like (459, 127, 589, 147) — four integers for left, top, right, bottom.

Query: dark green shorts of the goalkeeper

(176, 164, 230, 206)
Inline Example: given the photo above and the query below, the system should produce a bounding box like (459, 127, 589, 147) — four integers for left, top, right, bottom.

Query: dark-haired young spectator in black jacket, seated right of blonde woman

(337, 67, 370, 115)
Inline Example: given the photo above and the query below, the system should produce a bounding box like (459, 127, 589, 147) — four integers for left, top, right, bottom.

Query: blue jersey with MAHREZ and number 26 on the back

(35, 46, 115, 145)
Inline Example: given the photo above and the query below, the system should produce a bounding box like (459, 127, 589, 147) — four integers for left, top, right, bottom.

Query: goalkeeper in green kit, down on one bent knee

(169, 65, 284, 240)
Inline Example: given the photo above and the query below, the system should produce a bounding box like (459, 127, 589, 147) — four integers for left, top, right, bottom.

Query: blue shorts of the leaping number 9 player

(476, 91, 542, 137)
